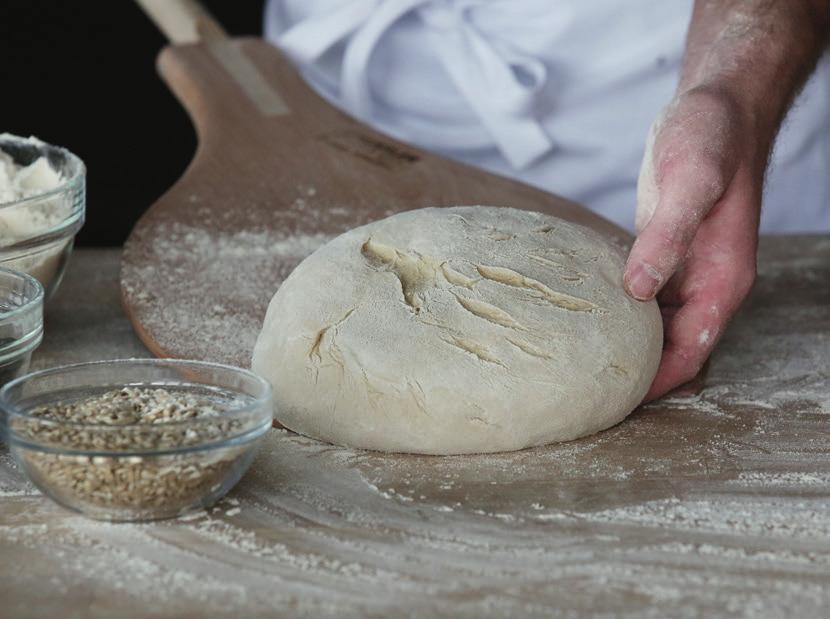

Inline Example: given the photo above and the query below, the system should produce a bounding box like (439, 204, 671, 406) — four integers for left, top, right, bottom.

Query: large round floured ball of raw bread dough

(253, 206, 662, 454)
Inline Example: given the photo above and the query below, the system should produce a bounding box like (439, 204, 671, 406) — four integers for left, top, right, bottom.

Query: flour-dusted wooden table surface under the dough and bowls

(0, 243, 830, 618)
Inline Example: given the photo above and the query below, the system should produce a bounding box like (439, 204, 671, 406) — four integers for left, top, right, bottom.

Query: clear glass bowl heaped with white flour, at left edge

(0, 133, 86, 299)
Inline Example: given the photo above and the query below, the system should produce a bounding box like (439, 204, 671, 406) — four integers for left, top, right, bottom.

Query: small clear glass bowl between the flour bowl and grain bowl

(0, 268, 43, 386)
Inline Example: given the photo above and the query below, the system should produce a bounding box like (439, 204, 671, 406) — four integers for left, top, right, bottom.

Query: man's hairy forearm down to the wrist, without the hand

(678, 0, 830, 134)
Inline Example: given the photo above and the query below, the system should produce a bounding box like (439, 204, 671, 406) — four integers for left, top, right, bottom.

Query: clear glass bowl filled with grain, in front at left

(0, 359, 273, 521)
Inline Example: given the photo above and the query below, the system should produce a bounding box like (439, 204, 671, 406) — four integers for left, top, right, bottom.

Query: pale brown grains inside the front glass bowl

(11, 387, 251, 519)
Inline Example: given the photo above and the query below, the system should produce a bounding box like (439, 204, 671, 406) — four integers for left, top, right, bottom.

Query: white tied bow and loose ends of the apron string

(277, 0, 553, 170)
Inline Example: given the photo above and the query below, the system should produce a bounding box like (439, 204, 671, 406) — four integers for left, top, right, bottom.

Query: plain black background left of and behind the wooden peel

(0, 0, 264, 246)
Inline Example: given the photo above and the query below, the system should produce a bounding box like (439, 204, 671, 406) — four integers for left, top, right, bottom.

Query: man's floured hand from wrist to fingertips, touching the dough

(625, 87, 765, 400)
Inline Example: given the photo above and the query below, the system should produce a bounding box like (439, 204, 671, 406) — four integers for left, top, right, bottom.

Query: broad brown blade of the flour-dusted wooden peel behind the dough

(121, 39, 629, 366)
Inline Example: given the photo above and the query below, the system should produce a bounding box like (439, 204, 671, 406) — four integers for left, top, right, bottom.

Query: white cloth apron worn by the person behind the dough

(265, 0, 830, 232)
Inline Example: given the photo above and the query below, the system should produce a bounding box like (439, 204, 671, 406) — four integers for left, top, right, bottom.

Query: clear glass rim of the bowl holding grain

(0, 357, 274, 432)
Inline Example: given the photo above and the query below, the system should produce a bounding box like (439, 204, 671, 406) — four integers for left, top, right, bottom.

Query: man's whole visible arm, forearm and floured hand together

(624, 0, 830, 401)
